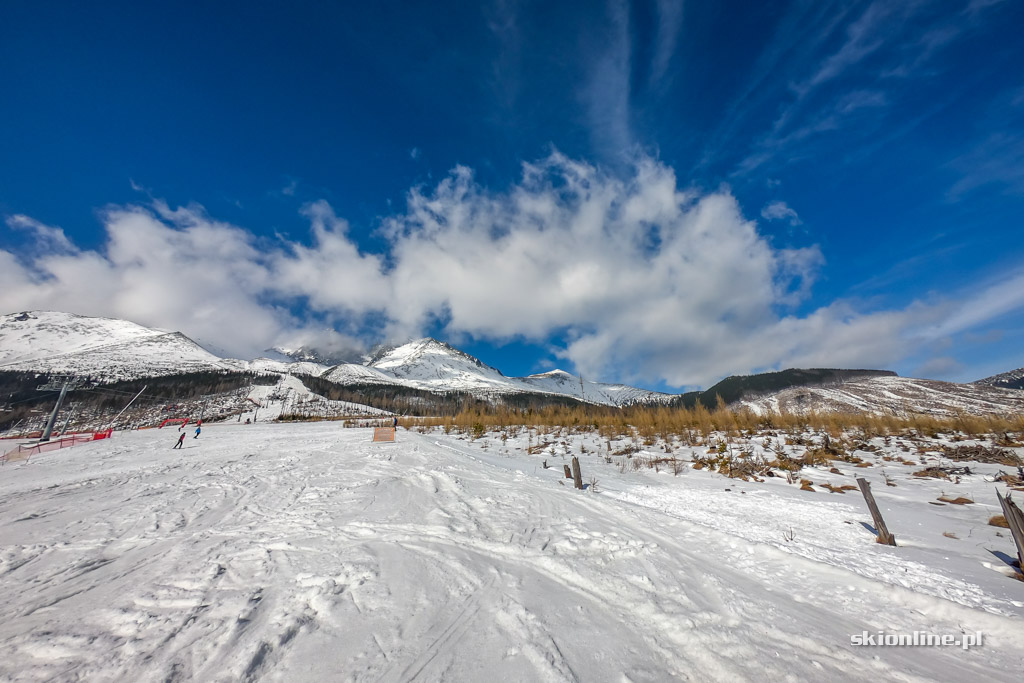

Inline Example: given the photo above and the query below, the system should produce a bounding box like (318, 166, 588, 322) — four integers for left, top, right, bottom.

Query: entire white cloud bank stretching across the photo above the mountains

(0, 153, 1021, 387)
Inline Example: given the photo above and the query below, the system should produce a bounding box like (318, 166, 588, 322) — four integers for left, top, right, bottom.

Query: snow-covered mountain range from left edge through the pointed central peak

(0, 311, 673, 405)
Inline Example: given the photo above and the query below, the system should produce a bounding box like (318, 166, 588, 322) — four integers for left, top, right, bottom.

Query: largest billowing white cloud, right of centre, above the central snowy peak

(380, 155, 933, 386)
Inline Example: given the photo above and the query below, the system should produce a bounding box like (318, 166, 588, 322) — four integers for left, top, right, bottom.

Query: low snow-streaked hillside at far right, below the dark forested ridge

(739, 377, 1024, 416)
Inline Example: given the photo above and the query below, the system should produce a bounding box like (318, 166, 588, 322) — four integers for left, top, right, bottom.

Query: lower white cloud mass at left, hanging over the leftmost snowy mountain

(0, 201, 380, 356)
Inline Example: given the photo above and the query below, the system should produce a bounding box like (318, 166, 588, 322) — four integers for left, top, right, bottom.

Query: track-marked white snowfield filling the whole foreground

(0, 423, 1024, 681)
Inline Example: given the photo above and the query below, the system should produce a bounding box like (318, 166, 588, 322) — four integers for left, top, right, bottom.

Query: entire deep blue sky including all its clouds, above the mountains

(0, 0, 1024, 390)
